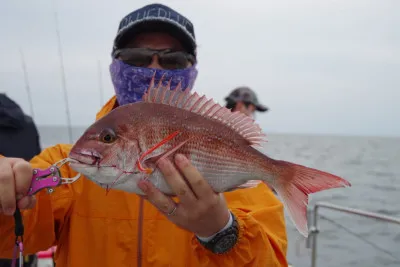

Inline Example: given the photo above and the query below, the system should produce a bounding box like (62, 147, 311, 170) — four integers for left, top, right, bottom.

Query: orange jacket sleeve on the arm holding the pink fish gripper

(0, 145, 72, 258)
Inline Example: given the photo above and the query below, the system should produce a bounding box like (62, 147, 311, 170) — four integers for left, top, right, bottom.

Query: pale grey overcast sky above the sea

(0, 0, 400, 136)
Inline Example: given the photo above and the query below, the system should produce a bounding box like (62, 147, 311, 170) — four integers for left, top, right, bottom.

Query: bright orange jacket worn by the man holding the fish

(0, 97, 287, 267)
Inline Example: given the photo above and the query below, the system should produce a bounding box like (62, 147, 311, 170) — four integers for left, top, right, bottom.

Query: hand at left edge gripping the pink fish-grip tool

(0, 158, 35, 215)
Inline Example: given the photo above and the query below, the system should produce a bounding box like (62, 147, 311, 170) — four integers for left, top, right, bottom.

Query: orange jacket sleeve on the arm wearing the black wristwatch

(192, 184, 288, 267)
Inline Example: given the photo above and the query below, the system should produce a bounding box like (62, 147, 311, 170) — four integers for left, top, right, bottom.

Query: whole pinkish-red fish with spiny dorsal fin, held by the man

(69, 80, 351, 236)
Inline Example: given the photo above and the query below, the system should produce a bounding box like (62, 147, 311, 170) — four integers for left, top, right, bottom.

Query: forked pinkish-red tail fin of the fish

(273, 161, 351, 237)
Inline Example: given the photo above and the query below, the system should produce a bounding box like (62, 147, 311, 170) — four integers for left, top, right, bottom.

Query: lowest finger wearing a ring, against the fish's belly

(138, 180, 177, 217)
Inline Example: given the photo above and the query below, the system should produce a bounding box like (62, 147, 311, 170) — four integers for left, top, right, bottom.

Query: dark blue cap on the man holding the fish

(112, 4, 196, 57)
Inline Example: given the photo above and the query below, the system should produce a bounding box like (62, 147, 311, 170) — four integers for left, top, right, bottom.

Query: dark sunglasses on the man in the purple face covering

(115, 48, 196, 70)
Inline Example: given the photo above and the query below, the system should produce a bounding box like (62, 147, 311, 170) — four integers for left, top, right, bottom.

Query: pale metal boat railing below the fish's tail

(306, 202, 400, 267)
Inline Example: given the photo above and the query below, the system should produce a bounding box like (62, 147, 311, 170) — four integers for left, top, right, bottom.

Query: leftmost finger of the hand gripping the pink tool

(0, 158, 16, 215)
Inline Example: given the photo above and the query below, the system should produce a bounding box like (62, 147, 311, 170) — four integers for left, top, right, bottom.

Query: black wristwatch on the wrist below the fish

(196, 212, 239, 254)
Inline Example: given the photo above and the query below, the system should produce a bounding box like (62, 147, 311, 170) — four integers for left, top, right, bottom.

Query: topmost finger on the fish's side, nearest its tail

(175, 154, 217, 199)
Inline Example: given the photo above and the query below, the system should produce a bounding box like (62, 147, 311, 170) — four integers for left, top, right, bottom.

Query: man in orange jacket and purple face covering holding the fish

(0, 4, 287, 267)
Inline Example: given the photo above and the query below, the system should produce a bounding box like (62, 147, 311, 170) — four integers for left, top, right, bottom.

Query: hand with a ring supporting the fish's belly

(138, 155, 230, 237)
